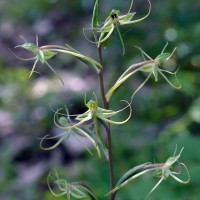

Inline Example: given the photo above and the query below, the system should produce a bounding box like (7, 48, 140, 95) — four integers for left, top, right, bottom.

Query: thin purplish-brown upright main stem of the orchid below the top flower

(97, 44, 115, 200)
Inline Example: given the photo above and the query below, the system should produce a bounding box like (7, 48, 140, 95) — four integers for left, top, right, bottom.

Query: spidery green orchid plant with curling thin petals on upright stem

(16, 0, 190, 200)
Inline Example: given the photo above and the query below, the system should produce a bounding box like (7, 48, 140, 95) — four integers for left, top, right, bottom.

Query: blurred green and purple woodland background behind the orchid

(0, 0, 200, 200)
